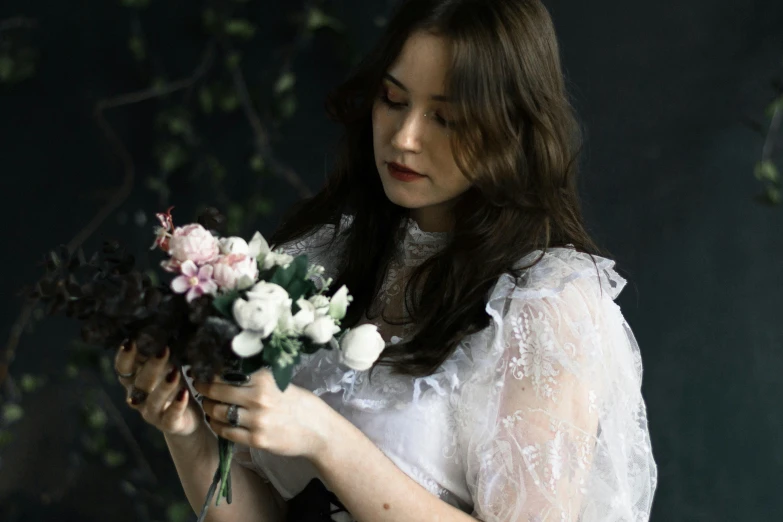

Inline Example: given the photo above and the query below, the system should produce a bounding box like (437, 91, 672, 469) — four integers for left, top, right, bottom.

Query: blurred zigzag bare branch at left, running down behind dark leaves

(0, 42, 215, 388)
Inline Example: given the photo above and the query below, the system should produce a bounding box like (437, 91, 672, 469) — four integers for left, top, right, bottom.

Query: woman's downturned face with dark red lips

(372, 32, 471, 232)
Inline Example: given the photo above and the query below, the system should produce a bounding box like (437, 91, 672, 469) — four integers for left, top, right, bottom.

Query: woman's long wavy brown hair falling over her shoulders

(270, 0, 602, 377)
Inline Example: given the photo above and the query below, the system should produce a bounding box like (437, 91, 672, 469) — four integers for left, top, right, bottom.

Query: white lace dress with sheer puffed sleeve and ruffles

(230, 216, 657, 522)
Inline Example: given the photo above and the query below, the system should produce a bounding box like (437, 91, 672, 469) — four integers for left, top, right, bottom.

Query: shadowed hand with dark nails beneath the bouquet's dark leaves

(114, 342, 203, 436)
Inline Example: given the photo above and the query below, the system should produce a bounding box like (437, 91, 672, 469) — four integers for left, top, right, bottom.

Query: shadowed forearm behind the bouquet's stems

(165, 418, 285, 522)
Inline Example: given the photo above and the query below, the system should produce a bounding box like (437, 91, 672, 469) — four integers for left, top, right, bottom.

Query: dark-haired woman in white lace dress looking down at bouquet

(116, 0, 657, 522)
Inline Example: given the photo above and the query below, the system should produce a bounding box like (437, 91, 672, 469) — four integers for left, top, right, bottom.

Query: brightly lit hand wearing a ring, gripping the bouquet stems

(193, 368, 335, 460)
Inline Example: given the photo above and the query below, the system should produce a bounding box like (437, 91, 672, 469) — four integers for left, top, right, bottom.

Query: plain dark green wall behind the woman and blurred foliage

(0, 0, 783, 522)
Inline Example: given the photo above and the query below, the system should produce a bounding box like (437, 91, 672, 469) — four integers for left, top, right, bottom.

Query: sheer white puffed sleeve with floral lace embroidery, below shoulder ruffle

(468, 270, 657, 522)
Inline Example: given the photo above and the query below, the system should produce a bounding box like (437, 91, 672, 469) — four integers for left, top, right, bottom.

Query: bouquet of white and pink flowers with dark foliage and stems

(33, 207, 384, 521)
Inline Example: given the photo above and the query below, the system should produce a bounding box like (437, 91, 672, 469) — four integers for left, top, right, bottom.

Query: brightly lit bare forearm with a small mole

(313, 412, 477, 522)
